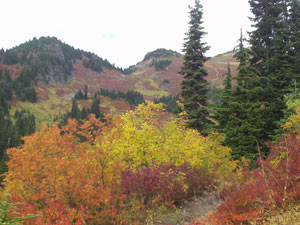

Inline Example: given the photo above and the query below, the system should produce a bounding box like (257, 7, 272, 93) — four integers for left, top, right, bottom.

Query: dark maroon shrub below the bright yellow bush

(121, 164, 213, 208)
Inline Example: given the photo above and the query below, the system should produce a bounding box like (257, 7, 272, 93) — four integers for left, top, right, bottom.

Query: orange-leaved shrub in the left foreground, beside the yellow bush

(5, 116, 118, 224)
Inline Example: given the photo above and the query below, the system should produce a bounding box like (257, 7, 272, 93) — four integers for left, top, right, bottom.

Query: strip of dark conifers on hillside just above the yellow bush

(98, 88, 145, 106)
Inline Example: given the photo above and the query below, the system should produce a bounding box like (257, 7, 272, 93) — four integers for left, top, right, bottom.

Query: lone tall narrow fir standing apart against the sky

(180, 0, 210, 134)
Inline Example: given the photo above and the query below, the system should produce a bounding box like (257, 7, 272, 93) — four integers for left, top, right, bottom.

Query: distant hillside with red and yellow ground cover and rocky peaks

(0, 37, 237, 124)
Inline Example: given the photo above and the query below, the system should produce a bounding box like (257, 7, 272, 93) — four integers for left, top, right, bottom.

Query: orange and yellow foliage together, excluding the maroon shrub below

(5, 102, 236, 224)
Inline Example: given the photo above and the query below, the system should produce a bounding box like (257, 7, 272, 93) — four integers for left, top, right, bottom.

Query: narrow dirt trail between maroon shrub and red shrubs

(155, 193, 223, 225)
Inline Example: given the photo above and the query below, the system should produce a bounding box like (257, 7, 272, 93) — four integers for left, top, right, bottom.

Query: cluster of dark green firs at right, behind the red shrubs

(211, 0, 300, 159)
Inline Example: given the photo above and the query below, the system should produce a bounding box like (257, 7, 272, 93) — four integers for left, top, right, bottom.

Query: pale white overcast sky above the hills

(0, 0, 251, 68)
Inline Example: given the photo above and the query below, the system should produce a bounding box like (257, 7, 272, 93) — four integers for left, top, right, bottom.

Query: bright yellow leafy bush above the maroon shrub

(90, 102, 236, 176)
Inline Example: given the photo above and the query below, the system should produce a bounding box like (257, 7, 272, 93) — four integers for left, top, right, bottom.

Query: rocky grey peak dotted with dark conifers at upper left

(3, 37, 82, 83)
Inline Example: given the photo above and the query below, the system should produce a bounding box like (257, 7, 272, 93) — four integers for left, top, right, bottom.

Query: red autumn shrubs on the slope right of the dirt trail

(199, 121, 300, 224)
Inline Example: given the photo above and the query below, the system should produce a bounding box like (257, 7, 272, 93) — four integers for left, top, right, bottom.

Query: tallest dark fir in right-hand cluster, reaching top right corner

(249, 0, 300, 140)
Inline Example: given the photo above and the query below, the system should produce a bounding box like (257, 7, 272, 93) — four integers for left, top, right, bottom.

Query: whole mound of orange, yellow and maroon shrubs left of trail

(5, 102, 236, 224)
